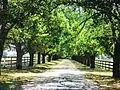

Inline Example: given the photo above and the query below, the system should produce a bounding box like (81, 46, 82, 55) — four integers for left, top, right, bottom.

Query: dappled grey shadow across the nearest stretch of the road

(20, 73, 99, 90)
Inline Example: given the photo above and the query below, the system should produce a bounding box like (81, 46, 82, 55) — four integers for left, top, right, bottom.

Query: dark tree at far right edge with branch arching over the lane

(58, 0, 120, 78)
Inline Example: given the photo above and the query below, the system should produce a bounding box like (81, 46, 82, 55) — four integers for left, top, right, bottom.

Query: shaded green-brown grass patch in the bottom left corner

(0, 74, 34, 90)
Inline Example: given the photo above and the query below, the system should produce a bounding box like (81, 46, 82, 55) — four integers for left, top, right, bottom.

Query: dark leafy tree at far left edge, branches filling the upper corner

(0, 0, 41, 69)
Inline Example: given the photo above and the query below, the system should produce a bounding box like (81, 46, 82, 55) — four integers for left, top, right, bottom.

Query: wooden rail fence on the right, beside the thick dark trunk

(95, 60, 113, 70)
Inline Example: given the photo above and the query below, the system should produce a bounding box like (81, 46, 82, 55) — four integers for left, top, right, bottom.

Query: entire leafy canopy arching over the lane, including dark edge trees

(0, 0, 120, 77)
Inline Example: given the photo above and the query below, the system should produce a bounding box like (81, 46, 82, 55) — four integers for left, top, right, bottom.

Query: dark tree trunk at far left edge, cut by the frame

(0, 0, 9, 75)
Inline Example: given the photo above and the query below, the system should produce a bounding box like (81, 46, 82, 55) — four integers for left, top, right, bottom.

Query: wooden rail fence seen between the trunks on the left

(1, 56, 36, 68)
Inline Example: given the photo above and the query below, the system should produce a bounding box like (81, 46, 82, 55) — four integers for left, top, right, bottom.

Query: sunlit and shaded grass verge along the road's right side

(72, 60, 120, 90)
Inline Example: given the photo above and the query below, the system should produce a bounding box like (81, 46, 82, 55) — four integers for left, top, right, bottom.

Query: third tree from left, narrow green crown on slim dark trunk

(25, 14, 41, 66)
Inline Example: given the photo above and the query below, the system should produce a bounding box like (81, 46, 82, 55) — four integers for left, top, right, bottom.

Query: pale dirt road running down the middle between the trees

(20, 59, 100, 90)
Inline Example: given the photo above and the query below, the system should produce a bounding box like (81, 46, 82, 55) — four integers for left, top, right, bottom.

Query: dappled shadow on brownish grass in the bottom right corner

(86, 74, 120, 90)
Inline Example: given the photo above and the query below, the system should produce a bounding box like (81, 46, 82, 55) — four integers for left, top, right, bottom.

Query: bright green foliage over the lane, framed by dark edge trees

(5, 0, 118, 60)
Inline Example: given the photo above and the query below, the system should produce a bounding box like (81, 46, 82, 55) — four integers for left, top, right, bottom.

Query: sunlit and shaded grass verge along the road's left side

(0, 60, 60, 90)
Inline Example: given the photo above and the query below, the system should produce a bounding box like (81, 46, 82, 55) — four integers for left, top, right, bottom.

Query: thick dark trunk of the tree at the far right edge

(113, 40, 120, 79)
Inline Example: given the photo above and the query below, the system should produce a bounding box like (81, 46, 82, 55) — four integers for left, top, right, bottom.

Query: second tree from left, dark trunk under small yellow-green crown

(7, 27, 28, 69)
